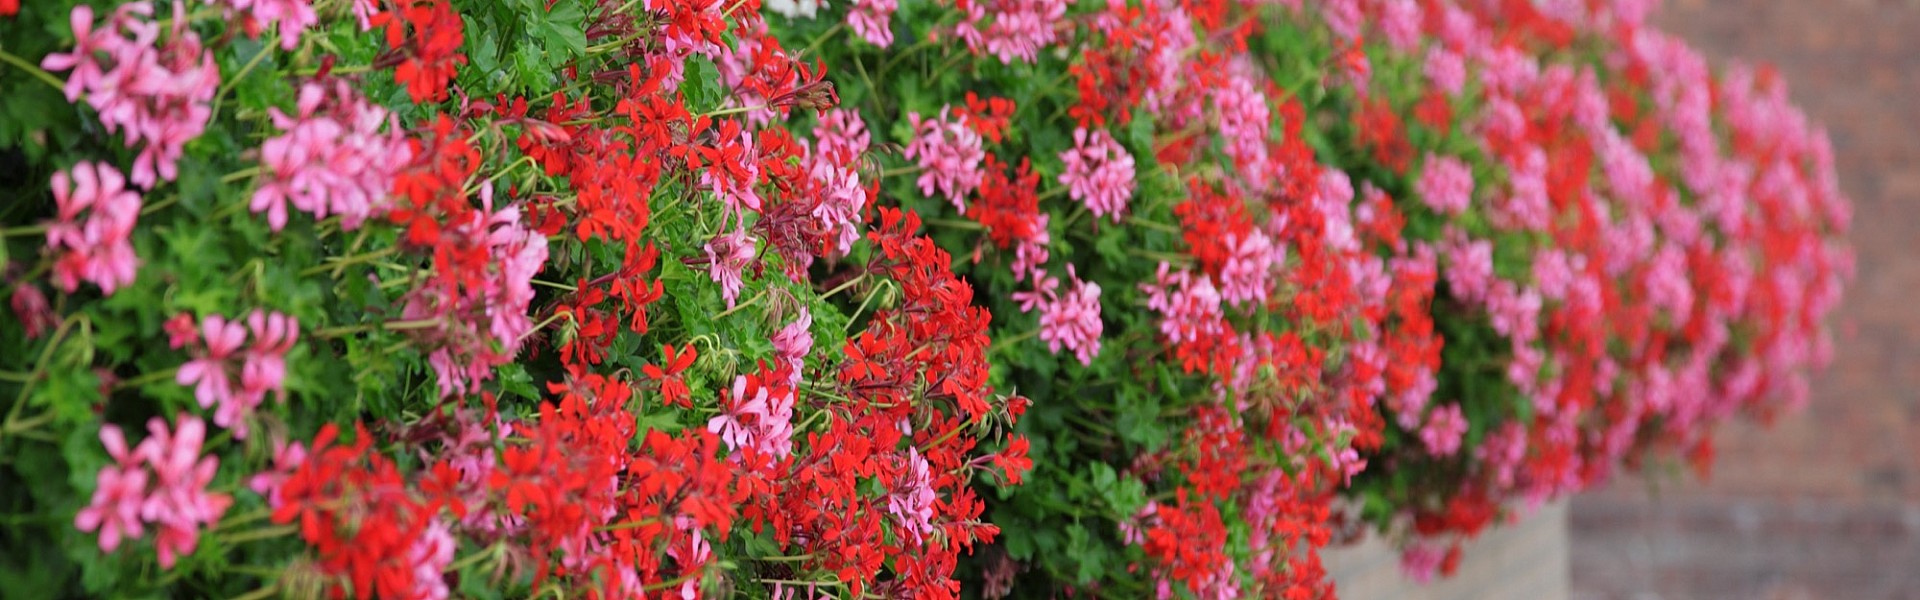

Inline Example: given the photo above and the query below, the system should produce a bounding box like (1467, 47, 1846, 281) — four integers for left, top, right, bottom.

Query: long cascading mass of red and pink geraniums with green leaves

(0, 0, 1851, 598)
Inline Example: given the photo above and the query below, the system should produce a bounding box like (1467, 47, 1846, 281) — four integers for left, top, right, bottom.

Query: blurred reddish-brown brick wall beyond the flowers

(1571, 0, 1920, 600)
